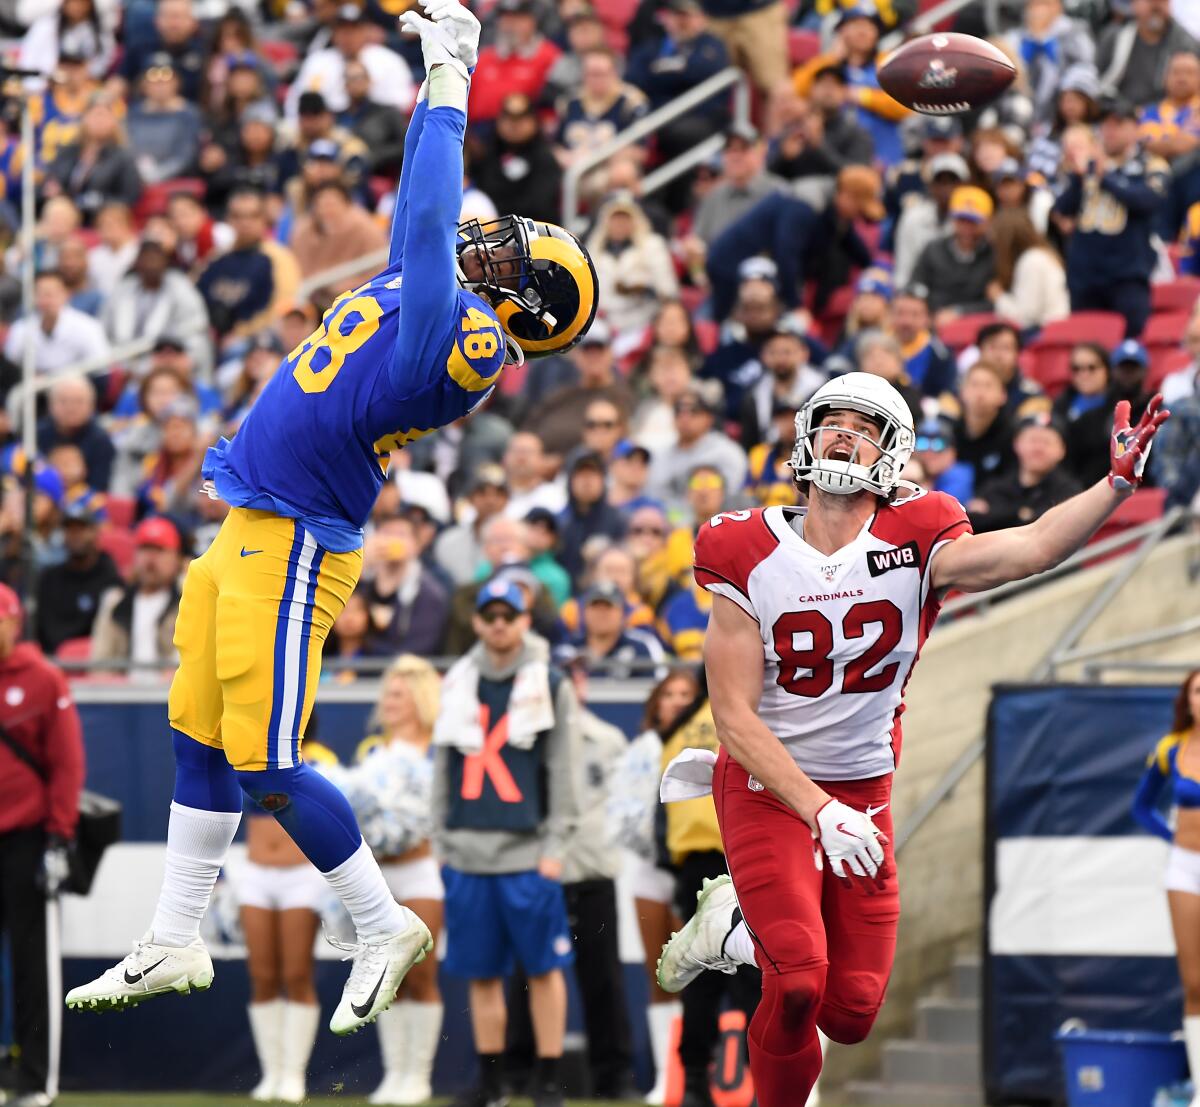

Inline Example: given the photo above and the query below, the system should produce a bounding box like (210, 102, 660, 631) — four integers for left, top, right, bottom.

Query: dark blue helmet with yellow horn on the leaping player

(458, 215, 596, 358)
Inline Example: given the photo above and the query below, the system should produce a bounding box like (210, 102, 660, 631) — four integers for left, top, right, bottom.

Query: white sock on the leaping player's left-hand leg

(150, 802, 241, 946)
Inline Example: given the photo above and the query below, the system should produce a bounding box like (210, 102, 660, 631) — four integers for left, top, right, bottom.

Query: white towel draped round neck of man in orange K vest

(433, 653, 554, 754)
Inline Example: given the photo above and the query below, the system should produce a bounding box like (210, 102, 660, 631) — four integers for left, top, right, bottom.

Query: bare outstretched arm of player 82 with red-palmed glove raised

(931, 396, 1168, 592)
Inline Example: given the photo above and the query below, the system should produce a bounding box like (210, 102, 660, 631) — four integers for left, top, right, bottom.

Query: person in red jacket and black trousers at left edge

(0, 585, 84, 1107)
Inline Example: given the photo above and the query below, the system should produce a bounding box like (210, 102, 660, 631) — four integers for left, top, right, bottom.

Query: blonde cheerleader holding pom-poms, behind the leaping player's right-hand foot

(350, 654, 443, 1103)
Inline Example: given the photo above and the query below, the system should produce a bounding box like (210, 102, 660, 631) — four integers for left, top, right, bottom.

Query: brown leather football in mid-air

(878, 32, 1016, 115)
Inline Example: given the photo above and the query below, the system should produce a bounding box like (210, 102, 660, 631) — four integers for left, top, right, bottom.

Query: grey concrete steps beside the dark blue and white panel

(842, 955, 984, 1107)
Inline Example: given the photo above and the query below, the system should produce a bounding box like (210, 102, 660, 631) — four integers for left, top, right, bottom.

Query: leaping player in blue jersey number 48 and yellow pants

(66, 0, 596, 1034)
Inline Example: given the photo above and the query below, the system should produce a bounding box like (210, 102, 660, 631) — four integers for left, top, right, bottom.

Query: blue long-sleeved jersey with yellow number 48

(204, 103, 505, 552)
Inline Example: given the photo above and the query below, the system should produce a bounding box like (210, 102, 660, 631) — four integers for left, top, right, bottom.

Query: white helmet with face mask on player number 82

(792, 373, 916, 497)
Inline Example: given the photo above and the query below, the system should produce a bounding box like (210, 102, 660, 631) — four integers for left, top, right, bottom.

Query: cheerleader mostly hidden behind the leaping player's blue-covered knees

(234, 722, 337, 1103)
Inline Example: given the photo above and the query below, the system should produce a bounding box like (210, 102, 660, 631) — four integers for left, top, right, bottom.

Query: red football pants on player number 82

(713, 749, 900, 1107)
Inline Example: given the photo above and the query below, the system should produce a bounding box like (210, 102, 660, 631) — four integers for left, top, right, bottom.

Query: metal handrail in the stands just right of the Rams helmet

(562, 66, 750, 231)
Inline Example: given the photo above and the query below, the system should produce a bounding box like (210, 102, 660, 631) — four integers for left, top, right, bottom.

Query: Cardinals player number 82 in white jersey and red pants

(659, 373, 1168, 1107)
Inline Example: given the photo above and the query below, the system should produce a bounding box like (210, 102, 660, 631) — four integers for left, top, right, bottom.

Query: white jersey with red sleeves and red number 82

(695, 492, 971, 780)
